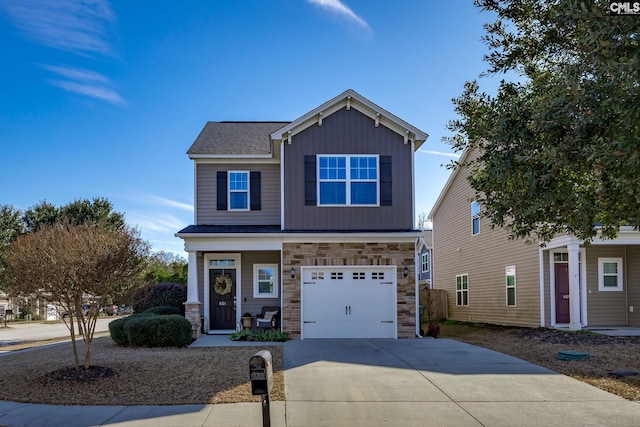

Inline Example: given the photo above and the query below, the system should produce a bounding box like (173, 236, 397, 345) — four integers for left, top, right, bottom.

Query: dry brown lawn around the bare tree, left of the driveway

(0, 336, 284, 405)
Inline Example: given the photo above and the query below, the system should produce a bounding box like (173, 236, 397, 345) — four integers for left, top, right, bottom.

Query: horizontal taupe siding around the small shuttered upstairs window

(195, 162, 280, 225)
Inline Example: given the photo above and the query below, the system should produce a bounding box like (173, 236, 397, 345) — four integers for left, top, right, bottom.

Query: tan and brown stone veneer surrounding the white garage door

(282, 243, 416, 339)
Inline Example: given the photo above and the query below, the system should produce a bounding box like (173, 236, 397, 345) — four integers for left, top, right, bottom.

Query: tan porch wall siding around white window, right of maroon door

(586, 245, 629, 326)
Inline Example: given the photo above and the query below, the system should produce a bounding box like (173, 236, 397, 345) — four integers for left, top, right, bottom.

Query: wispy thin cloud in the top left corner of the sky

(0, 0, 115, 55)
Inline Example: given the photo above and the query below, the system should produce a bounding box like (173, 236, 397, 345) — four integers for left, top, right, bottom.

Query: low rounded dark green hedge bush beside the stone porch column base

(124, 314, 192, 347)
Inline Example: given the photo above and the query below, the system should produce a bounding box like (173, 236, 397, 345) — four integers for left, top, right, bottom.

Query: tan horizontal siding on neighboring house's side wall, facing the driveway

(433, 149, 540, 326)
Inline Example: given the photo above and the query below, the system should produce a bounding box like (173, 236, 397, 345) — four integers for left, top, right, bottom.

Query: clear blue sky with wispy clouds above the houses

(0, 0, 500, 253)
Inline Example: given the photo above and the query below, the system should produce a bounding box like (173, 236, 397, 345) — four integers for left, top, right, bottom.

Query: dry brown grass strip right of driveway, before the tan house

(441, 322, 640, 401)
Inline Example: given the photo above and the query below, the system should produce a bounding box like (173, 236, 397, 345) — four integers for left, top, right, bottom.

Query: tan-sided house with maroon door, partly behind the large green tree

(430, 151, 640, 330)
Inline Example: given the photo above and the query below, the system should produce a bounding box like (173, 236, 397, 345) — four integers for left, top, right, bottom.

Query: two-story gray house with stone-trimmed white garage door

(176, 90, 427, 339)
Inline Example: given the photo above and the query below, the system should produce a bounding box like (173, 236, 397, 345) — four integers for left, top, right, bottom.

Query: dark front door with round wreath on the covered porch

(209, 268, 236, 329)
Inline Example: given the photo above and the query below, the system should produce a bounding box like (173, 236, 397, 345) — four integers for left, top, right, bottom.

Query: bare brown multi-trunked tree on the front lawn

(7, 221, 149, 369)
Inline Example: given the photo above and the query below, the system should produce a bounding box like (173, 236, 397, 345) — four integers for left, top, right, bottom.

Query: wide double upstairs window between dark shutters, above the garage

(318, 155, 379, 206)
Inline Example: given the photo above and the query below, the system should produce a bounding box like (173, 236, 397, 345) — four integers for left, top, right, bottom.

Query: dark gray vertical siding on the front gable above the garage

(284, 108, 414, 230)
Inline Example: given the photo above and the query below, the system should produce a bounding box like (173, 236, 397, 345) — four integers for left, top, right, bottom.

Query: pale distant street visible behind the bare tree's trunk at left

(0, 317, 118, 351)
